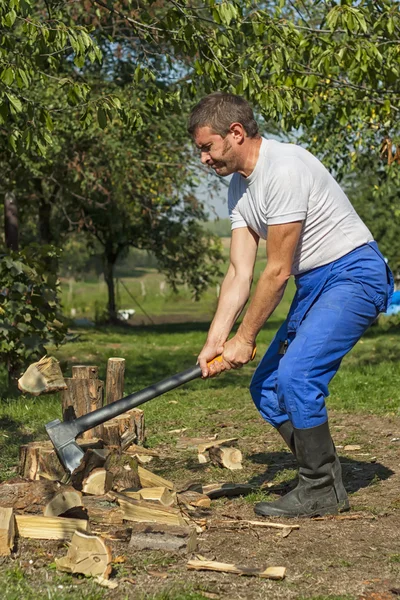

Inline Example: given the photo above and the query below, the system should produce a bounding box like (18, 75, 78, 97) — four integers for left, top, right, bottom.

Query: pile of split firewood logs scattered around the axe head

(0, 359, 288, 585)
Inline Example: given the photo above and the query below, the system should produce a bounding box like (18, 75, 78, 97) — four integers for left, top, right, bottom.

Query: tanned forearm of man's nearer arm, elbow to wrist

(237, 267, 288, 344)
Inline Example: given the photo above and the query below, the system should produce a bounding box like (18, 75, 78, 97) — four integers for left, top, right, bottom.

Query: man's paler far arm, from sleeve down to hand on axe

(199, 227, 259, 377)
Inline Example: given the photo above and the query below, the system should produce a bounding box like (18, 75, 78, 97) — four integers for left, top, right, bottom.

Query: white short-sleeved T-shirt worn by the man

(228, 138, 373, 275)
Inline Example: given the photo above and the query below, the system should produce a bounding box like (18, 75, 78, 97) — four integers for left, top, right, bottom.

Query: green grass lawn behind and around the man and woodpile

(0, 270, 400, 600)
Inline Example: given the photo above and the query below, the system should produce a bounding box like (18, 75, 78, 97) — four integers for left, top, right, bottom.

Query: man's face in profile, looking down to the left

(194, 127, 237, 177)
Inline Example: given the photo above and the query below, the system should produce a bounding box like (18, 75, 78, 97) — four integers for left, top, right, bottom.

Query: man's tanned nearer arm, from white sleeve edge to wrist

(237, 222, 303, 345)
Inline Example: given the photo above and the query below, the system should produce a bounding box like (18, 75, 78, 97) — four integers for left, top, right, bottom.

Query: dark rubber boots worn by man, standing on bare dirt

(254, 422, 348, 517)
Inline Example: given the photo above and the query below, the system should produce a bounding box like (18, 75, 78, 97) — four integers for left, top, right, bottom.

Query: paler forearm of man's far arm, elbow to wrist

(207, 271, 251, 346)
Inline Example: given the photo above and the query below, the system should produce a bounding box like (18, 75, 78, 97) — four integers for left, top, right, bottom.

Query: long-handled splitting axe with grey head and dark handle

(46, 348, 256, 473)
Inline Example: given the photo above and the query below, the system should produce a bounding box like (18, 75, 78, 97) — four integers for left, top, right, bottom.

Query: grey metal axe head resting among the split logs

(46, 419, 85, 473)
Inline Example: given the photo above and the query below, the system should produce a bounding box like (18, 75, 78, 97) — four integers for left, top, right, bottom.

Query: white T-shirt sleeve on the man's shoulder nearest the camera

(263, 157, 312, 225)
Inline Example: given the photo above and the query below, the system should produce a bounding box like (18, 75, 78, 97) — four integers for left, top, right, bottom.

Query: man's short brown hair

(188, 92, 258, 138)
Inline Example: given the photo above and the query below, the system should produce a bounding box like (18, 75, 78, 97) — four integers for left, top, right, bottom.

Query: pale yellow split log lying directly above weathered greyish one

(110, 492, 186, 525)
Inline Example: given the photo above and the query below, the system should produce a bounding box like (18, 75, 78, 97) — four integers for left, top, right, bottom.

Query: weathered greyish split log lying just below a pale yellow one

(129, 523, 197, 554)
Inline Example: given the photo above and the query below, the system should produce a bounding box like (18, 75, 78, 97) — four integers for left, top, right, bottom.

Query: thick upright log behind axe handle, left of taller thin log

(61, 365, 104, 439)
